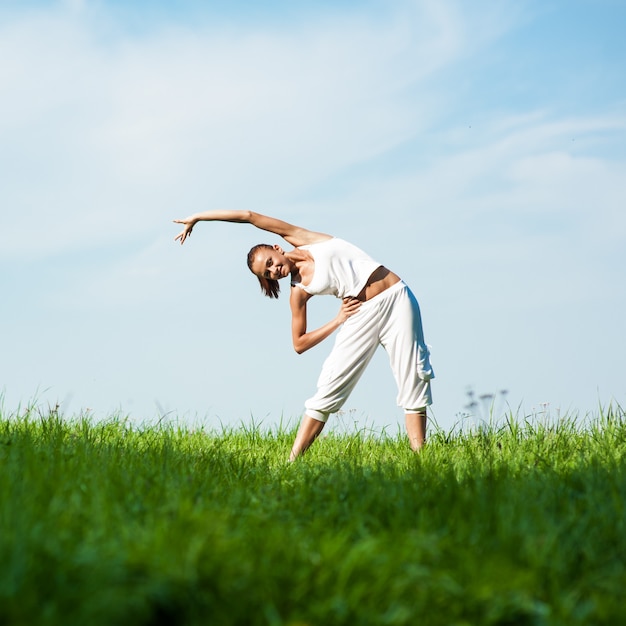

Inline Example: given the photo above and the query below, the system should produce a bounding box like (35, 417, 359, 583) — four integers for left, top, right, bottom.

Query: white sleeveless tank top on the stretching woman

(291, 237, 381, 298)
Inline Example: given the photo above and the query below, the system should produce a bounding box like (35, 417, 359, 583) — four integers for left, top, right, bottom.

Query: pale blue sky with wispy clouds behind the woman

(0, 0, 626, 432)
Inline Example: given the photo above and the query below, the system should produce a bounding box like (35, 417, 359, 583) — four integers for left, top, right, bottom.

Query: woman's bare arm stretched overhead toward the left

(174, 210, 331, 247)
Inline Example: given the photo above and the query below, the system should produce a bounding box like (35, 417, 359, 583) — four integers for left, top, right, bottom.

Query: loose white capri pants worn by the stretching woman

(304, 281, 434, 422)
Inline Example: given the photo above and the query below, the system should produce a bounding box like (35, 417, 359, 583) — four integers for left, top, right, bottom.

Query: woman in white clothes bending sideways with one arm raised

(174, 211, 434, 461)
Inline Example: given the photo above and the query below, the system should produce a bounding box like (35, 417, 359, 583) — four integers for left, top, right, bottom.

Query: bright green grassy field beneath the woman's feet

(0, 408, 626, 626)
